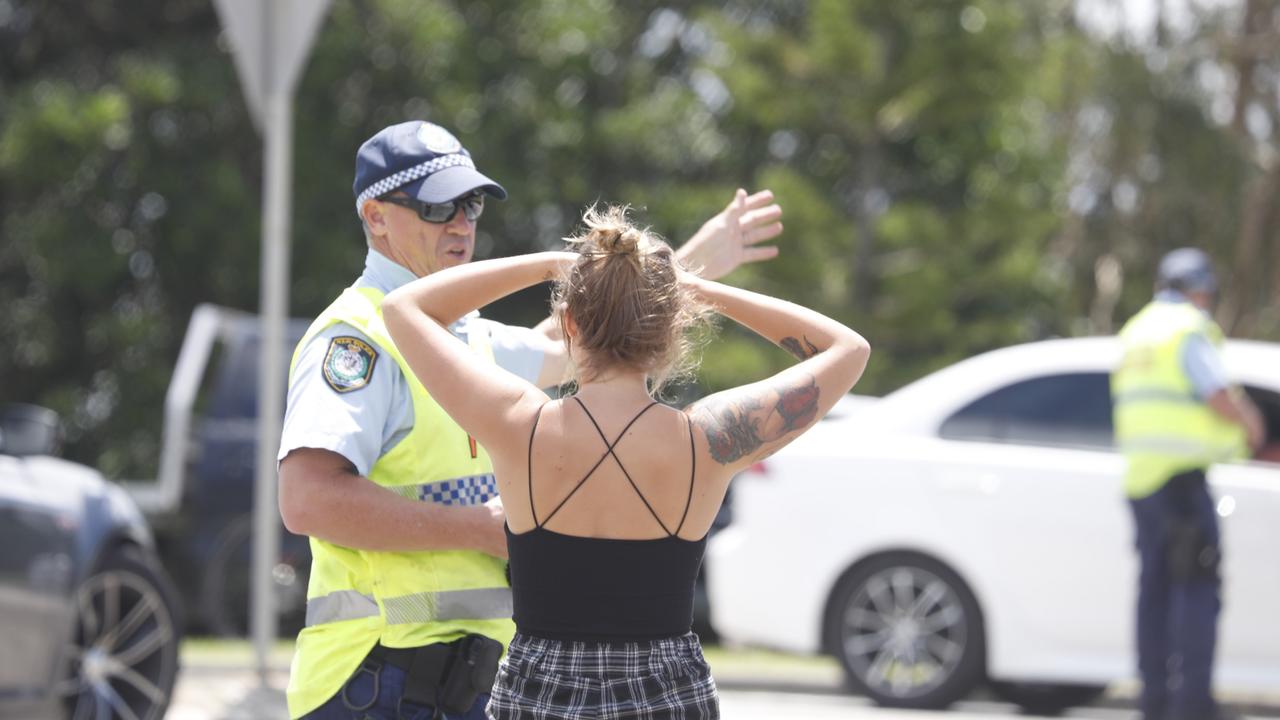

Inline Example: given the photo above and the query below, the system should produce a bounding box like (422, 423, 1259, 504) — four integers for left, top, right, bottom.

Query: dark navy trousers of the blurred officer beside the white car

(1130, 470, 1221, 720)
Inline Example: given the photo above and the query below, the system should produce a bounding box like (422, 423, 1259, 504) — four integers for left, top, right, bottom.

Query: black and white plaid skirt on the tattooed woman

(488, 633, 719, 720)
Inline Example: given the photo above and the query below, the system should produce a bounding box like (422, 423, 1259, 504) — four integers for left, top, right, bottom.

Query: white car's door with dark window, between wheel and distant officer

(937, 373, 1135, 683)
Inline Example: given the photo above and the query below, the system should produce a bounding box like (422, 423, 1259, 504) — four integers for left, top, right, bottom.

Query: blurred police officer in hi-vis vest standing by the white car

(1111, 247, 1263, 720)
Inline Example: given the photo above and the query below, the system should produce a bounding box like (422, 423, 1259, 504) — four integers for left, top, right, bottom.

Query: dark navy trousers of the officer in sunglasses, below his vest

(303, 650, 489, 720)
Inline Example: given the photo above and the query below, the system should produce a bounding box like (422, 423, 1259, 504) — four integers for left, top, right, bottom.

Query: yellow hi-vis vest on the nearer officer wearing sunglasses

(288, 288, 516, 717)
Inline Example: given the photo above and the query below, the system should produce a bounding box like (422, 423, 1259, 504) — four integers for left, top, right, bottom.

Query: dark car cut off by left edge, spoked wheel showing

(0, 405, 180, 720)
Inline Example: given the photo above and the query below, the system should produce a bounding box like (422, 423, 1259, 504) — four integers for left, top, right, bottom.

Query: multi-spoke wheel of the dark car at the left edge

(55, 547, 182, 720)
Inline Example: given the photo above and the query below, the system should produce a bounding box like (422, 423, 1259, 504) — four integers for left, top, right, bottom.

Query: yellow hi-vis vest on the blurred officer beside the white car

(1111, 301, 1245, 498)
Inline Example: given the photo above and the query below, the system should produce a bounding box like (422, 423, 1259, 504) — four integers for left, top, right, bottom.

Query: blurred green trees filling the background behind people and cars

(0, 0, 1280, 477)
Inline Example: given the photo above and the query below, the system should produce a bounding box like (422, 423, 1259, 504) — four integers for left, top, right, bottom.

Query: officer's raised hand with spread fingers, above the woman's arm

(676, 188, 782, 279)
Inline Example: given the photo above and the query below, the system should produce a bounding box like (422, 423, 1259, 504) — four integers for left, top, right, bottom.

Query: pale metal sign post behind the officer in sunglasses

(250, 3, 293, 687)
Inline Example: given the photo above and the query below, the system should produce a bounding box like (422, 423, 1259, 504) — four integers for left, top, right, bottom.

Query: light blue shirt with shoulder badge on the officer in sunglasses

(276, 250, 547, 477)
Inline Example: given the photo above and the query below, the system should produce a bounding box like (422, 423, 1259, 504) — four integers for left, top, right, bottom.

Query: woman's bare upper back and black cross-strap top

(508, 397, 723, 642)
